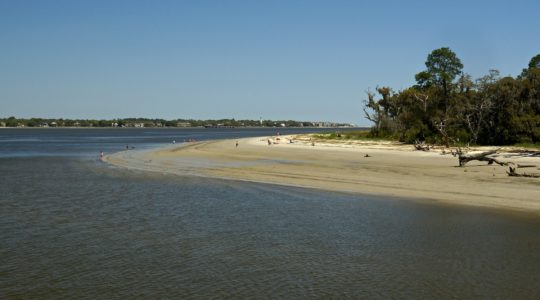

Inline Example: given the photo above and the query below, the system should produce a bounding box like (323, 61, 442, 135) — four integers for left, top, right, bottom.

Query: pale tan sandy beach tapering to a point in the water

(103, 136, 540, 213)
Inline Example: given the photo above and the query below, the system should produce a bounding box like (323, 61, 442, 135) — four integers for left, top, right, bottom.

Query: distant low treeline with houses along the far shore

(0, 117, 348, 127)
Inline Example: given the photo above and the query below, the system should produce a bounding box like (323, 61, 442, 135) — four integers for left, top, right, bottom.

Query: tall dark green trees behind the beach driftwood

(364, 48, 540, 146)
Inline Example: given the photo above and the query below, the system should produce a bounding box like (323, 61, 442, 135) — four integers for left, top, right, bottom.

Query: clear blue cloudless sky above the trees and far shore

(0, 0, 540, 126)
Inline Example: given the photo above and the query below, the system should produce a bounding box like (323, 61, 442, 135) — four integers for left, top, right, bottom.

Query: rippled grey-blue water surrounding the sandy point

(0, 129, 540, 299)
